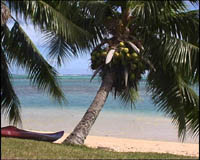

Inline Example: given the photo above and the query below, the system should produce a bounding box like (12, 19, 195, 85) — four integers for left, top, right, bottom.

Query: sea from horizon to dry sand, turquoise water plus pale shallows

(1, 75, 198, 143)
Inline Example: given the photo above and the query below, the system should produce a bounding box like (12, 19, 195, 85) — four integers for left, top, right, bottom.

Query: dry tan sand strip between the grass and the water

(54, 133, 199, 157)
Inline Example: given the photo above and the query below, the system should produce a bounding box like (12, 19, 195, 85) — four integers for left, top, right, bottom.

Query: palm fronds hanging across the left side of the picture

(1, 1, 99, 125)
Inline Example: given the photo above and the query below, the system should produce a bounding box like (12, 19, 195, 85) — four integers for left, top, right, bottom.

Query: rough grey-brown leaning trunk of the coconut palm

(63, 73, 113, 144)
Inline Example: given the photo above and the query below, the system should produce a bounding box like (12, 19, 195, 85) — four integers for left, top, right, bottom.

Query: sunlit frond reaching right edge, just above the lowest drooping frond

(146, 35, 199, 84)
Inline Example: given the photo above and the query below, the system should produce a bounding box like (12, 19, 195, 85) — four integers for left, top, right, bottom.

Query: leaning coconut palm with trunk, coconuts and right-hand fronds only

(64, 0, 199, 144)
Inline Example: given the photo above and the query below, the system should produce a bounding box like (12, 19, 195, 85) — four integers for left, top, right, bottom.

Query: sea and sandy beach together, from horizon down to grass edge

(1, 75, 199, 156)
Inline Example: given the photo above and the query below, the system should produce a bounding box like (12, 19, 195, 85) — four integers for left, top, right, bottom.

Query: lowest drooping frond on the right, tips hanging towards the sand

(147, 62, 199, 140)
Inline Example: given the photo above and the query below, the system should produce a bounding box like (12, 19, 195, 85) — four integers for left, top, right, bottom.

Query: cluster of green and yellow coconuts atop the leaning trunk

(91, 42, 146, 90)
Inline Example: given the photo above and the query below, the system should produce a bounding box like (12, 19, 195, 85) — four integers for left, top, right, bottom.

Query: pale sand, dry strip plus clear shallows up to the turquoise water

(1, 109, 199, 156)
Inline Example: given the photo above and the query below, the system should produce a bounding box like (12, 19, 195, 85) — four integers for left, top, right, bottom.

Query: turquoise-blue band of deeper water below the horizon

(12, 75, 163, 116)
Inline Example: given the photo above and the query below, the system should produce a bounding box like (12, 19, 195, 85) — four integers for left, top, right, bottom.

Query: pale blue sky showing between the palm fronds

(9, 2, 199, 75)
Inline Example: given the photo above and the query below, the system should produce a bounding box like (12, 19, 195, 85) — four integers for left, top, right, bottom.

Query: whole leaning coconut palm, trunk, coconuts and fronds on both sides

(3, 0, 199, 144)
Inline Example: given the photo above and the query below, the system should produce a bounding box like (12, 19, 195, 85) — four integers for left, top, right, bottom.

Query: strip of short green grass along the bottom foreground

(1, 138, 197, 159)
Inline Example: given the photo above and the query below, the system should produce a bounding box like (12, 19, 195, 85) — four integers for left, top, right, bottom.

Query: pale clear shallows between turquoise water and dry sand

(1, 109, 199, 144)
